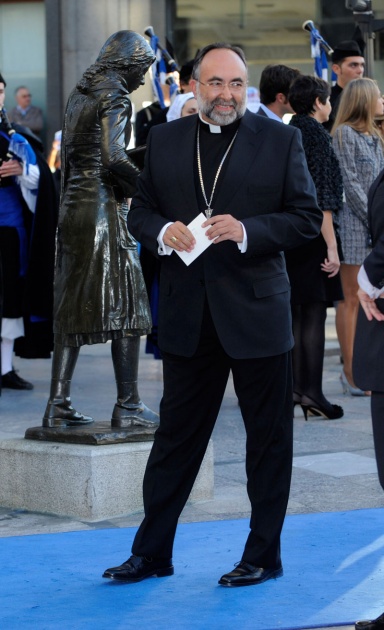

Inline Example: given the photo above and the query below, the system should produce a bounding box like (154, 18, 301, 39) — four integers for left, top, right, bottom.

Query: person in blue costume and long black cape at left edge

(0, 75, 57, 390)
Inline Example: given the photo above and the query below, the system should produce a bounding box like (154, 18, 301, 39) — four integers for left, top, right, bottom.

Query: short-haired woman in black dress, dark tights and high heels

(285, 75, 344, 420)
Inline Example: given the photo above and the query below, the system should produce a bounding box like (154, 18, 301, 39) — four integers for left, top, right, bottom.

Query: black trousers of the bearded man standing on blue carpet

(132, 309, 293, 568)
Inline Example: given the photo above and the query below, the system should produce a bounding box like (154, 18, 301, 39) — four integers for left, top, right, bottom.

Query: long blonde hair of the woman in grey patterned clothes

(331, 78, 381, 139)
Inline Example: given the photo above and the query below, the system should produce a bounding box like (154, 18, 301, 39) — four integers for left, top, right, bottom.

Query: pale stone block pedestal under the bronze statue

(0, 439, 213, 522)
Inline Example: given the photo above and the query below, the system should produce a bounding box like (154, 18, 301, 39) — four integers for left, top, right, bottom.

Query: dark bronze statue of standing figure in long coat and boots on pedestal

(43, 31, 158, 428)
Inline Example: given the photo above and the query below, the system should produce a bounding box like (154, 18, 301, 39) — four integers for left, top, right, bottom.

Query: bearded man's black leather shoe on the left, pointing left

(103, 556, 174, 582)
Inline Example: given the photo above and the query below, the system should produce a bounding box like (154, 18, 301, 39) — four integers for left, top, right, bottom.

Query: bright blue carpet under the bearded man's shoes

(0, 509, 384, 630)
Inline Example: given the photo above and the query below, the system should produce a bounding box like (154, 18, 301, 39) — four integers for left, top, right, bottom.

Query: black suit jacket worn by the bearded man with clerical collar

(128, 111, 322, 359)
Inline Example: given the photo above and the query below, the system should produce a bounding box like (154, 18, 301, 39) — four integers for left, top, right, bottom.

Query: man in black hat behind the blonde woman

(323, 40, 365, 131)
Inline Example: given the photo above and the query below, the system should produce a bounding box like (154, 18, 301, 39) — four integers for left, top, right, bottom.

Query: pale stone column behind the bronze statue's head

(45, 0, 166, 142)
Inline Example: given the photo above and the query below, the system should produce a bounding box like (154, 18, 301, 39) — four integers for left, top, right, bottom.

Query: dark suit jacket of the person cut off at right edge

(353, 170, 384, 392)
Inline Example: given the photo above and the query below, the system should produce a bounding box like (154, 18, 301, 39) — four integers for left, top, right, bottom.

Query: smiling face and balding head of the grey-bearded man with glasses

(191, 48, 248, 125)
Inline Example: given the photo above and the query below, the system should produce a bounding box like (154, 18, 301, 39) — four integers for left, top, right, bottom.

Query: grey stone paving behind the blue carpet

(0, 309, 384, 630)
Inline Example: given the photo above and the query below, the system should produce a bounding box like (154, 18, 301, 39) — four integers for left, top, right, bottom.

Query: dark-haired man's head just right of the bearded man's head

(257, 64, 300, 122)
